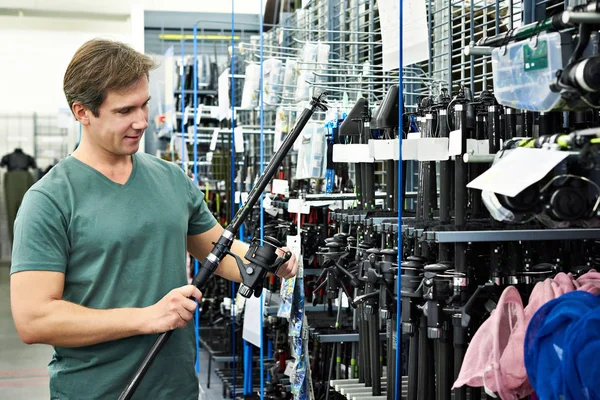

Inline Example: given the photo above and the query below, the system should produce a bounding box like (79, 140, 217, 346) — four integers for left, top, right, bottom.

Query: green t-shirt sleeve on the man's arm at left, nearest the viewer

(10, 189, 70, 274)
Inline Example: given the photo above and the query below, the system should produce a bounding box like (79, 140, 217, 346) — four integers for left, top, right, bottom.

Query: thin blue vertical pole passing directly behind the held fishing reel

(259, 0, 265, 400)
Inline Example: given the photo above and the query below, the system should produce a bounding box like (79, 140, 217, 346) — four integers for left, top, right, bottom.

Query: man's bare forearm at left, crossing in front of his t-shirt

(19, 300, 149, 347)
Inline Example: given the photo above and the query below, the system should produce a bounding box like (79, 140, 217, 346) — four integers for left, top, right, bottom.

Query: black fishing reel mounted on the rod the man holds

(228, 236, 292, 298)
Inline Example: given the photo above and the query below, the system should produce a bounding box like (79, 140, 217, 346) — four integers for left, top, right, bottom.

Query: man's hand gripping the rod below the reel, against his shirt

(144, 285, 202, 333)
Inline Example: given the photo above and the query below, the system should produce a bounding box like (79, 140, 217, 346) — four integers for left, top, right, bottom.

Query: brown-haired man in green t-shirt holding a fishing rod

(11, 40, 297, 400)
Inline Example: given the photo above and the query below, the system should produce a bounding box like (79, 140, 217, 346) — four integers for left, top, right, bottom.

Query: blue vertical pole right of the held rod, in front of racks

(394, 0, 404, 400)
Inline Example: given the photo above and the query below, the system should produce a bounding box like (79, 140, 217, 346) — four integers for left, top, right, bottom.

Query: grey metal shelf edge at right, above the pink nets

(434, 229, 600, 243)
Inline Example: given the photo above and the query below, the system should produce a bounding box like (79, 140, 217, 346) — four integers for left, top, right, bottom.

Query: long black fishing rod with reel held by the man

(119, 92, 327, 400)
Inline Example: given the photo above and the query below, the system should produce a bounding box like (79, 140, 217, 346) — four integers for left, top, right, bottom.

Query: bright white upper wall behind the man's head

(0, 16, 131, 114)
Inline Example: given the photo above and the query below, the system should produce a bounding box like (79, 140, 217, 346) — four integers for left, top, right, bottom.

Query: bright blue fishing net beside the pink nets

(525, 291, 600, 400)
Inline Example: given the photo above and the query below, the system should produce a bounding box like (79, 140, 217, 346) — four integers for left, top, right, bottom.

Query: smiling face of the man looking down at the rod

(88, 77, 150, 156)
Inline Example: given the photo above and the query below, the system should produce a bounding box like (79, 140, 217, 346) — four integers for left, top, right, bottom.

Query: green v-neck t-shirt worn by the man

(11, 153, 217, 400)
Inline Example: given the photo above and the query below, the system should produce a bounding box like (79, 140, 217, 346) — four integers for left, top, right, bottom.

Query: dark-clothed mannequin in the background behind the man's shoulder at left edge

(0, 148, 37, 243)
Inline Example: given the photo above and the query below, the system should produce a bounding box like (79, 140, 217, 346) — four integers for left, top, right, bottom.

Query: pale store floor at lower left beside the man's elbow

(0, 265, 52, 400)
